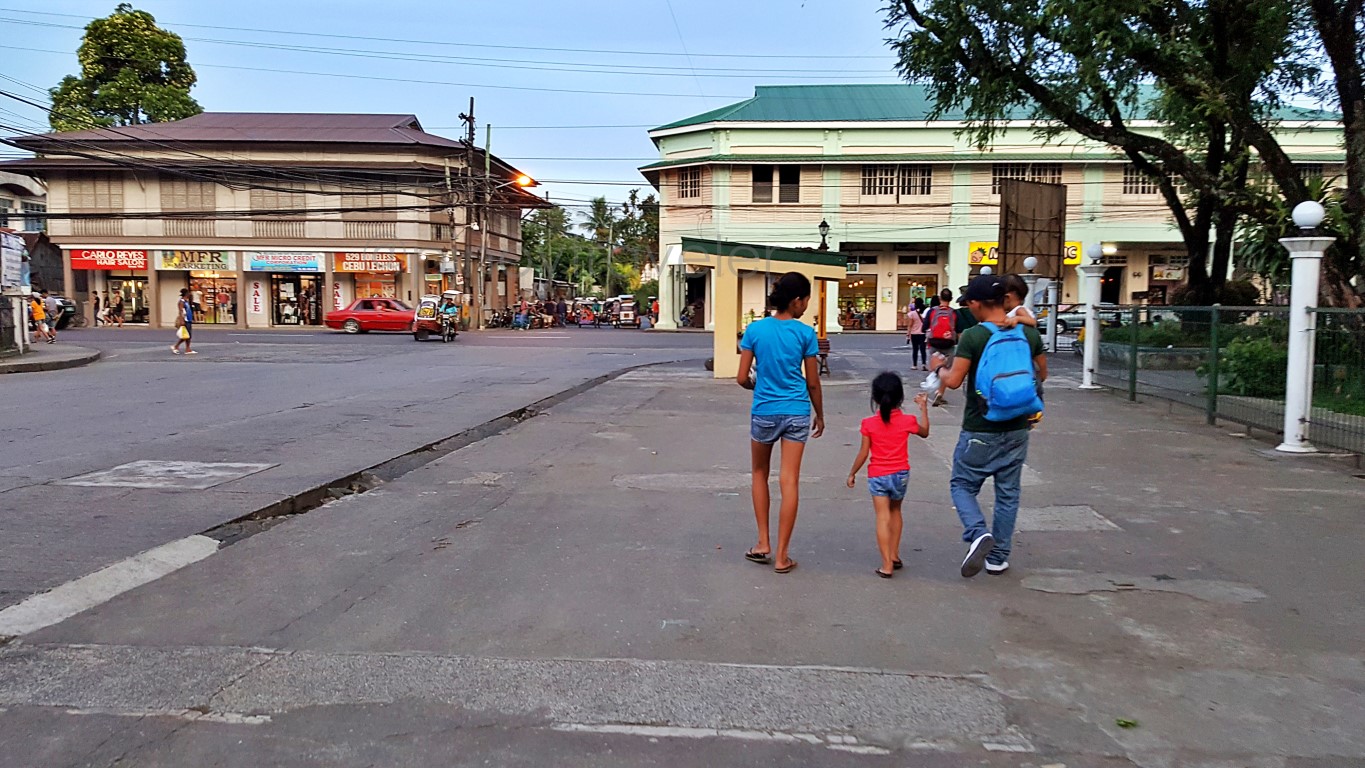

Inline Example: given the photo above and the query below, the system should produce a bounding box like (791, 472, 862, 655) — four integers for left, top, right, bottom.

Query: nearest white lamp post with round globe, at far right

(1275, 201, 1335, 453)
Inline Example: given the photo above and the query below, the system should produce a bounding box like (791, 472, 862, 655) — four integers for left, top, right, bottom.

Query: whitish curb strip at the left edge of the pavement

(0, 533, 218, 636)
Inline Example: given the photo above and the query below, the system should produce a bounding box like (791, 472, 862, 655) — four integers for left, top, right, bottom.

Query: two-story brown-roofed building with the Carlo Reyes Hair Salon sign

(0, 112, 545, 327)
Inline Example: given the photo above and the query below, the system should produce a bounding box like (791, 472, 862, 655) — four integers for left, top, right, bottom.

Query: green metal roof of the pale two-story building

(654, 83, 1340, 131)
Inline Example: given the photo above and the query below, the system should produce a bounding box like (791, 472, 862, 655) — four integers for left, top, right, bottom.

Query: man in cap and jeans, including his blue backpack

(934, 274, 1047, 578)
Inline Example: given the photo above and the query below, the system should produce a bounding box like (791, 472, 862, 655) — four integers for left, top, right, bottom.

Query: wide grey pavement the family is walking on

(0, 364, 1365, 768)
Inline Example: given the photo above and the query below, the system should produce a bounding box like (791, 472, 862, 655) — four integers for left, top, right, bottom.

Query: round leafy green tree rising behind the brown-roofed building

(49, 3, 203, 131)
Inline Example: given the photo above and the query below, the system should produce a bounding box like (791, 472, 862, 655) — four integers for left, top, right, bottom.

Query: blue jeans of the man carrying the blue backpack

(951, 430, 1029, 565)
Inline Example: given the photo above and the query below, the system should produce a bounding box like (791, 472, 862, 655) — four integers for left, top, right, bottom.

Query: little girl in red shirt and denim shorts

(848, 371, 930, 578)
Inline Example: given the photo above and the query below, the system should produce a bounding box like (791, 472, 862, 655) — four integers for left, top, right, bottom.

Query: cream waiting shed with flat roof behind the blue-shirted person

(683, 237, 848, 379)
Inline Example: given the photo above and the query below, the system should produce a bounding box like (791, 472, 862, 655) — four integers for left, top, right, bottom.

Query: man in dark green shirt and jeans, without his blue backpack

(930, 274, 1047, 578)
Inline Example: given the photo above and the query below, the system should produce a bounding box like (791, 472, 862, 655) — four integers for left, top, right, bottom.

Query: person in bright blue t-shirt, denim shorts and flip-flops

(736, 271, 824, 573)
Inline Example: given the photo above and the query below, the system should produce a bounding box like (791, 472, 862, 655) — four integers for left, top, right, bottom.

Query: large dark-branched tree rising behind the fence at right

(886, 0, 1365, 304)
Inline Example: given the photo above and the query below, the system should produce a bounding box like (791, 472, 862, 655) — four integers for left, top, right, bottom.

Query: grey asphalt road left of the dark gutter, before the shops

(0, 327, 710, 608)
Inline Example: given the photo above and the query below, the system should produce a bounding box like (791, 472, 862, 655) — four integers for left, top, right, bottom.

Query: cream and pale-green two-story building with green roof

(640, 85, 1345, 331)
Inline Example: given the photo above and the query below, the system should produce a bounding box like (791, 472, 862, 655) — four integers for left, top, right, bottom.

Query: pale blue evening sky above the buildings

(0, 0, 897, 220)
